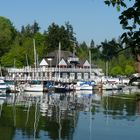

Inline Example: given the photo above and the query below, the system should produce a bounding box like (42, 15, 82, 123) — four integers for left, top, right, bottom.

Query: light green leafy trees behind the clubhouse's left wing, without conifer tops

(1, 33, 44, 67)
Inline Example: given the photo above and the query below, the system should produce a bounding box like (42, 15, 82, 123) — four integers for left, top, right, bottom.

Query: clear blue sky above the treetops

(0, 0, 123, 44)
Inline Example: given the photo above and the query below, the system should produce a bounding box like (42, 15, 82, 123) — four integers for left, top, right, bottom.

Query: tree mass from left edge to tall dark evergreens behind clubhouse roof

(0, 18, 78, 67)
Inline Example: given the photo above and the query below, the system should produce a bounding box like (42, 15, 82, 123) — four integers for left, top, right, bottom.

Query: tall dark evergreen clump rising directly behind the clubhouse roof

(45, 22, 77, 52)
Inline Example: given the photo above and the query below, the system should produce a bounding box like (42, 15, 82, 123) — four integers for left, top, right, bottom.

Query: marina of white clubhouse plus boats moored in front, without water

(0, 48, 130, 92)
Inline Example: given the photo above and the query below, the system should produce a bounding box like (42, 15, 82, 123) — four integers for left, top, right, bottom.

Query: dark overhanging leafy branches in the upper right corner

(105, 0, 140, 72)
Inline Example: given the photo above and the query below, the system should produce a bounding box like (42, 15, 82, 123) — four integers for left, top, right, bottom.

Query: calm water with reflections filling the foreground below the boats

(0, 92, 140, 140)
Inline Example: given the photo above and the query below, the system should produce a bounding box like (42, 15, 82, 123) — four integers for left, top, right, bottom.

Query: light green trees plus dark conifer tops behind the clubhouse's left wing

(1, 22, 45, 67)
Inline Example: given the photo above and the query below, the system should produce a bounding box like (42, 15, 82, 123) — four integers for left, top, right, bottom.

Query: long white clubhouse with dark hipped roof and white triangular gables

(7, 50, 103, 82)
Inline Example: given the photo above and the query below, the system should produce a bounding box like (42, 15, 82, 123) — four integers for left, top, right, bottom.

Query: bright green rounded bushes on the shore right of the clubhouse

(95, 43, 135, 76)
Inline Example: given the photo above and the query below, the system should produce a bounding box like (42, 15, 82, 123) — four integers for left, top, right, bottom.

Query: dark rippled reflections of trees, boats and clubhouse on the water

(0, 90, 139, 140)
